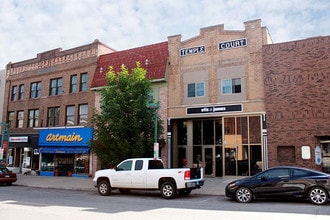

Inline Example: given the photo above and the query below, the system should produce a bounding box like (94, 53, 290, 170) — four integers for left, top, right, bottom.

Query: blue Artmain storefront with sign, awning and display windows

(39, 128, 93, 177)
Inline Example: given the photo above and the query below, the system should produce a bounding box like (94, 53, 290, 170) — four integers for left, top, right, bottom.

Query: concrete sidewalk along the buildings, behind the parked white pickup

(13, 174, 235, 195)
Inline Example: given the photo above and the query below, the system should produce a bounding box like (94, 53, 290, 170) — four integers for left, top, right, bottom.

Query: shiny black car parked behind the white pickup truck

(226, 166, 330, 205)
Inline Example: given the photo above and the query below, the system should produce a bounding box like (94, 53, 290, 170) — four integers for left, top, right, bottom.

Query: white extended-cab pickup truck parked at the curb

(93, 158, 204, 199)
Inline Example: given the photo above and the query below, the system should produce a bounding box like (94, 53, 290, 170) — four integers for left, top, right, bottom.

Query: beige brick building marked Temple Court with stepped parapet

(168, 20, 271, 176)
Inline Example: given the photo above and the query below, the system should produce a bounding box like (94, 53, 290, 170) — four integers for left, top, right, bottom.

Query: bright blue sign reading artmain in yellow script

(39, 128, 93, 146)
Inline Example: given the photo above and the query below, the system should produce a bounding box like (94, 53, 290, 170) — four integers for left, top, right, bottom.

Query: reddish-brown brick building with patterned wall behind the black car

(262, 36, 330, 173)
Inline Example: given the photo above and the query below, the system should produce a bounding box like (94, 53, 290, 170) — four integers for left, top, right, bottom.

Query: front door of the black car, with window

(254, 168, 290, 197)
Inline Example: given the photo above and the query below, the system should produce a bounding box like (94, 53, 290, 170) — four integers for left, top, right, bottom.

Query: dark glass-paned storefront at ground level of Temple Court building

(172, 107, 265, 177)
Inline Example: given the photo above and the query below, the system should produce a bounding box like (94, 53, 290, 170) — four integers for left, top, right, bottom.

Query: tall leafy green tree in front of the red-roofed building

(91, 62, 163, 168)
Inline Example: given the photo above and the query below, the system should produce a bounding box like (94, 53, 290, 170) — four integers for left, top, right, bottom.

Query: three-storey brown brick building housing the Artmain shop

(3, 40, 113, 175)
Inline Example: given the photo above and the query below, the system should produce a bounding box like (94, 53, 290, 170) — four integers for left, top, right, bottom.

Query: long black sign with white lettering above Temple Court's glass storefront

(187, 104, 242, 115)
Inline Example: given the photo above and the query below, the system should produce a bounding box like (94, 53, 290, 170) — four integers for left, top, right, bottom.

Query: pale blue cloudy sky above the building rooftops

(0, 0, 330, 70)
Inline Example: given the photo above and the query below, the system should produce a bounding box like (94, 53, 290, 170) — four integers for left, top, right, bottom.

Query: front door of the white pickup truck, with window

(111, 160, 133, 188)
